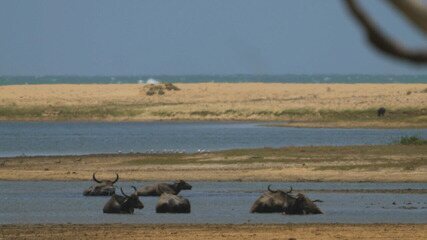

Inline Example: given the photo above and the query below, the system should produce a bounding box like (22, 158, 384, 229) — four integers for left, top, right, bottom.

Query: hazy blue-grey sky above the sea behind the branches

(0, 0, 427, 75)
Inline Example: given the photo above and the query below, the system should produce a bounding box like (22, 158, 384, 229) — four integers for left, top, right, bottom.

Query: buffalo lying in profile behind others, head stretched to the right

(138, 180, 192, 196)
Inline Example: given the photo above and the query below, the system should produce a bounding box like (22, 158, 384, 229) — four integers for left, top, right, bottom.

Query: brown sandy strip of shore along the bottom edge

(0, 224, 427, 240)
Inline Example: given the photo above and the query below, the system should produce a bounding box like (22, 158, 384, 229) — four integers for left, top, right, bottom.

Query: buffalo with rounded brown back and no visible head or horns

(156, 193, 191, 213)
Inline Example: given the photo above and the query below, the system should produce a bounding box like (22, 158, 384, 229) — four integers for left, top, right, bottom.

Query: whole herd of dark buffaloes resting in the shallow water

(83, 173, 322, 215)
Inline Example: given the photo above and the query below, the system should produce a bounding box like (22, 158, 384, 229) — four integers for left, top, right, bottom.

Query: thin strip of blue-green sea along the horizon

(0, 74, 427, 85)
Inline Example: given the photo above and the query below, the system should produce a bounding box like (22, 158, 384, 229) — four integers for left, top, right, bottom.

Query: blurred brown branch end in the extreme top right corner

(387, 0, 427, 34)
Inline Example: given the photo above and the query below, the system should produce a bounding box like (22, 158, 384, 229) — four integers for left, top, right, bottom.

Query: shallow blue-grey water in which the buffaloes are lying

(0, 181, 427, 224)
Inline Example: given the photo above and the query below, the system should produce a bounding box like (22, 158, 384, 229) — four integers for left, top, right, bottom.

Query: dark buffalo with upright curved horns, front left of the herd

(102, 186, 144, 214)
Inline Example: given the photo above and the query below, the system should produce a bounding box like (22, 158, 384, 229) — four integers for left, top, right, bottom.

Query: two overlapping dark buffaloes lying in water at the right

(251, 185, 322, 214)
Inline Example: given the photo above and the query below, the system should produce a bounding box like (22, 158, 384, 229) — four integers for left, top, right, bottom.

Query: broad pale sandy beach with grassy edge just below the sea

(0, 83, 427, 127)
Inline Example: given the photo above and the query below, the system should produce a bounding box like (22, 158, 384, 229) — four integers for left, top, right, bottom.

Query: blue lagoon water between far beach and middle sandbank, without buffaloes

(0, 122, 427, 157)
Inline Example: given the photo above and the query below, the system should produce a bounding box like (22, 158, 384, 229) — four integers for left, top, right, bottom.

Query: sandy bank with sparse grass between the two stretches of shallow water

(0, 145, 427, 182)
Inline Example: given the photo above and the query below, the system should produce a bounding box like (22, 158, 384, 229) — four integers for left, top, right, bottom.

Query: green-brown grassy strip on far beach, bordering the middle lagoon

(0, 104, 427, 127)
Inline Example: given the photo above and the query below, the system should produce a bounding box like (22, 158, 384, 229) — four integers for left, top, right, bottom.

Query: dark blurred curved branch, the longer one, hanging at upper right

(345, 0, 427, 64)
